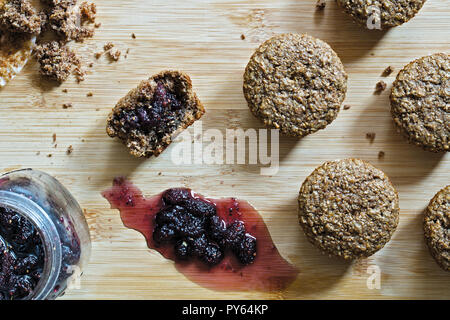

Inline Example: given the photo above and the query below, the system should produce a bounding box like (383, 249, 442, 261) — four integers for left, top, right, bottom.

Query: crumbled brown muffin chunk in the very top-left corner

(0, 0, 46, 35)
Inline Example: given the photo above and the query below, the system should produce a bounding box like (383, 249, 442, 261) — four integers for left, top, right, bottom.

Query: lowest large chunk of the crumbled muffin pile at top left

(36, 41, 80, 83)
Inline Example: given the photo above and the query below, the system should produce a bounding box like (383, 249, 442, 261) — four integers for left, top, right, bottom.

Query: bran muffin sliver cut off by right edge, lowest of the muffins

(424, 185, 450, 271)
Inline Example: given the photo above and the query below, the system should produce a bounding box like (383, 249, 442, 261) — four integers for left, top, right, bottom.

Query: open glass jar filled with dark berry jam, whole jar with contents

(0, 169, 91, 300)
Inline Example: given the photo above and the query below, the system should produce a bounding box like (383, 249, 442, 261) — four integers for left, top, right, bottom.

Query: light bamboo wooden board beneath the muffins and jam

(0, 0, 450, 299)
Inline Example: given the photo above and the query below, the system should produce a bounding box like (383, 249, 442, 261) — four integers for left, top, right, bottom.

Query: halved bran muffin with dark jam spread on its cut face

(106, 71, 205, 157)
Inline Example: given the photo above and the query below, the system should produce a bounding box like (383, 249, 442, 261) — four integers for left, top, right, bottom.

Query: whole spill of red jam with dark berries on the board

(102, 178, 298, 292)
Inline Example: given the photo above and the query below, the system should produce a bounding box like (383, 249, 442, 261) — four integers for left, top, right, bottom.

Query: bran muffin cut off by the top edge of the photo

(337, 0, 426, 29)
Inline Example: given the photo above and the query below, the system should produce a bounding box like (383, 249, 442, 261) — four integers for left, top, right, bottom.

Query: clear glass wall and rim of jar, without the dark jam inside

(0, 169, 91, 300)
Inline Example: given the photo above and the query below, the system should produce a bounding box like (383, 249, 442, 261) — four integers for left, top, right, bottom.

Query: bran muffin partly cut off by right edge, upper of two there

(390, 53, 450, 152)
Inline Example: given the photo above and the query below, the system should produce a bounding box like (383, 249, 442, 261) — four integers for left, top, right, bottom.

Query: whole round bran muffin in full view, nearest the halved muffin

(244, 33, 347, 137)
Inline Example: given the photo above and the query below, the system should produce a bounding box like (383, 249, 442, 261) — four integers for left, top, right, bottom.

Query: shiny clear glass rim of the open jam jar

(0, 191, 62, 300)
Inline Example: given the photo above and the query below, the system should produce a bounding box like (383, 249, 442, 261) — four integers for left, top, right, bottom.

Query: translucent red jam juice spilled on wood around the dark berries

(102, 178, 298, 292)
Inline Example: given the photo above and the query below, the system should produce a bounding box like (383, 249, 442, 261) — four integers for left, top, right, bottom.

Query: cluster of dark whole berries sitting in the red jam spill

(153, 189, 256, 266)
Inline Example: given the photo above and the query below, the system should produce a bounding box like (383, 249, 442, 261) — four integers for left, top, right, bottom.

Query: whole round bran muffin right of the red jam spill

(298, 159, 399, 260)
